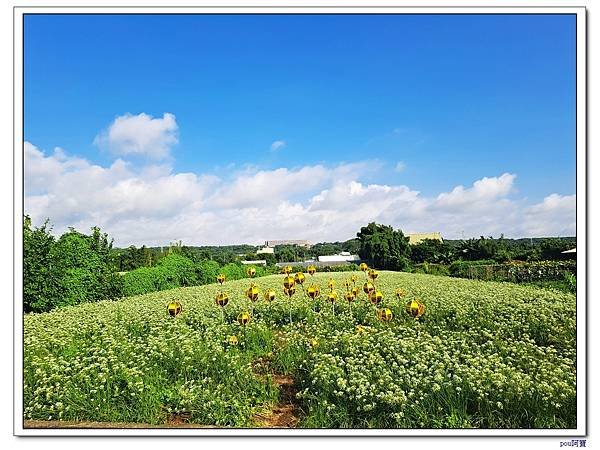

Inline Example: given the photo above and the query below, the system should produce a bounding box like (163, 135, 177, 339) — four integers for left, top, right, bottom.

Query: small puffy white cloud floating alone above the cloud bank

(94, 113, 178, 160)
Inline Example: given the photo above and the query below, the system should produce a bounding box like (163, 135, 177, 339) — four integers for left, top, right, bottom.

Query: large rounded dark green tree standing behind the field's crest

(357, 222, 411, 270)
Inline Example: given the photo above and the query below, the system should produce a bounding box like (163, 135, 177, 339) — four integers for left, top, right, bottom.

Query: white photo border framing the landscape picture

(13, 6, 589, 438)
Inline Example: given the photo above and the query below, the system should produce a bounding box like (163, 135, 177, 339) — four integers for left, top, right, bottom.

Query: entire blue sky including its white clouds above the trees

(24, 15, 575, 246)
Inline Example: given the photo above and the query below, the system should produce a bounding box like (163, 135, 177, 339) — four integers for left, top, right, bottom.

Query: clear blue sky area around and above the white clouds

(25, 15, 576, 244)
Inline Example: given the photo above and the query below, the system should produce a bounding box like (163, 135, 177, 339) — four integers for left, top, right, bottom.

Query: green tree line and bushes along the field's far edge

(23, 216, 575, 312)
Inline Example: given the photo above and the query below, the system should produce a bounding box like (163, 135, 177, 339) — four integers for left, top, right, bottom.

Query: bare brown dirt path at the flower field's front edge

(254, 374, 300, 428)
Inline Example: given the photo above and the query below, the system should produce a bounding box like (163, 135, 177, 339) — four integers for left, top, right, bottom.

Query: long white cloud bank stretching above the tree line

(25, 143, 575, 246)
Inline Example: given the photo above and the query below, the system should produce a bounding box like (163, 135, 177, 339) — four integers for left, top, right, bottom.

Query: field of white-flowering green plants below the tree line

(24, 272, 576, 428)
